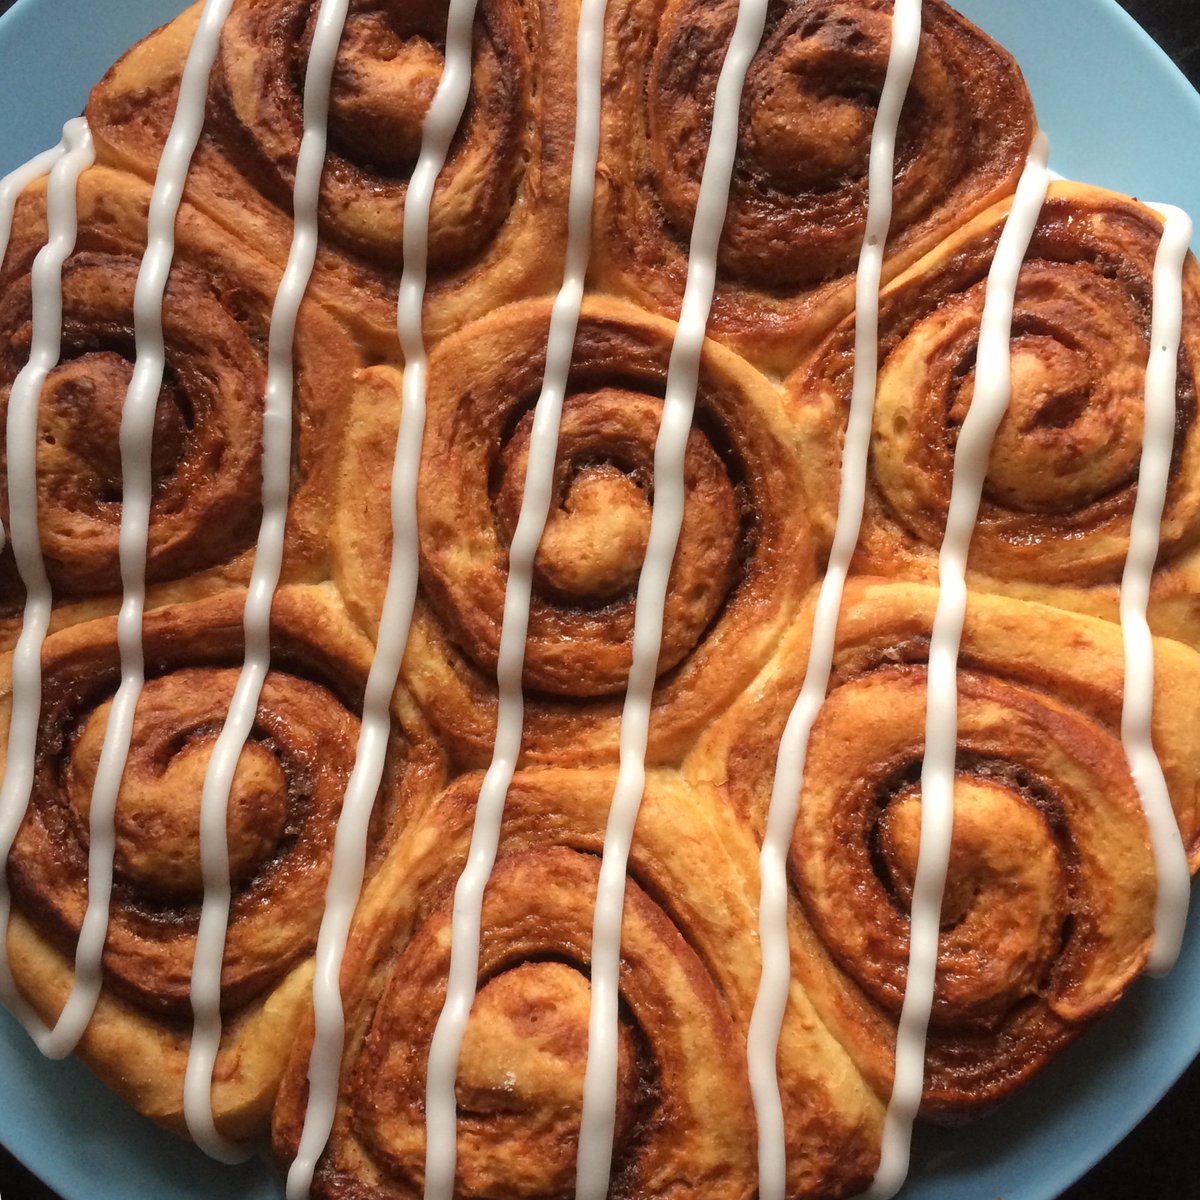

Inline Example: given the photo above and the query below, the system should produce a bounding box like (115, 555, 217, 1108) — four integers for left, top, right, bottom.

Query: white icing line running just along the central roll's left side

(288, 0, 476, 1200)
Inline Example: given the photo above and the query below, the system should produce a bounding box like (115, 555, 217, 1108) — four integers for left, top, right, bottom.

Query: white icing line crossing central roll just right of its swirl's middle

(575, 0, 767, 1200)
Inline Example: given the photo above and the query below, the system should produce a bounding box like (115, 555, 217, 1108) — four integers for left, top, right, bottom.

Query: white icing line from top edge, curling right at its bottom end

(184, 0, 347, 1159)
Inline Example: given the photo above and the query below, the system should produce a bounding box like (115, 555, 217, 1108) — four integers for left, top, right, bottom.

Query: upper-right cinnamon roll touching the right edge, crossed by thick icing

(787, 182, 1200, 647)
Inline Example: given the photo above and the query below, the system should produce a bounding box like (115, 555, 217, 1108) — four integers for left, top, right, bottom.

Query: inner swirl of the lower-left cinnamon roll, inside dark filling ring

(68, 671, 288, 902)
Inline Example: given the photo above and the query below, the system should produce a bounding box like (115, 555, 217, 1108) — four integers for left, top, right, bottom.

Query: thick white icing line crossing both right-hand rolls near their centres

(866, 131, 1050, 1200)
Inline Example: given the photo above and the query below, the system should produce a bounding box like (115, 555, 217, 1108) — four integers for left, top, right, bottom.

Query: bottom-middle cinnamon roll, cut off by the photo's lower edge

(275, 769, 882, 1200)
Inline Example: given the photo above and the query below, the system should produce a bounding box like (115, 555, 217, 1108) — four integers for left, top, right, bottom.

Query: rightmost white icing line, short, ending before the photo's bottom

(1121, 205, 1192, 974)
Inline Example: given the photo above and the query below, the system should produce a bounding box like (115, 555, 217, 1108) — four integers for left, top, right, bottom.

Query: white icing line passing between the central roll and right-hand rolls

(746, 0, 922, 1200)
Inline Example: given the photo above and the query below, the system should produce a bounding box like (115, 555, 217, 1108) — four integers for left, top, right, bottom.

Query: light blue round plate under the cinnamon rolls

(0, 0, 1200, 1200)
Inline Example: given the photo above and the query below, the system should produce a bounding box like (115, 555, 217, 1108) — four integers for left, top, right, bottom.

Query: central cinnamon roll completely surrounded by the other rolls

(334, 299, 812, 764)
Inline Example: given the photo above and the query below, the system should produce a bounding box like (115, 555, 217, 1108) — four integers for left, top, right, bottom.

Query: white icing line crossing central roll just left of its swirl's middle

(425, 0, 606, 1200)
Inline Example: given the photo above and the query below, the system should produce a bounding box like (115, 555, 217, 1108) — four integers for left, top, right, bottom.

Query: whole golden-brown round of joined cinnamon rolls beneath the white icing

(0, 0, 1200, 1200)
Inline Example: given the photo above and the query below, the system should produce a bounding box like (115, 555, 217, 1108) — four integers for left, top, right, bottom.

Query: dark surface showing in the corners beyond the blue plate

(0, 0, 1200, 1200)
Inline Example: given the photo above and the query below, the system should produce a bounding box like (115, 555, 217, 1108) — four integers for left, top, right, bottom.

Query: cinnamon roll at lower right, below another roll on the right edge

(685, 580, 1200, 1117)
